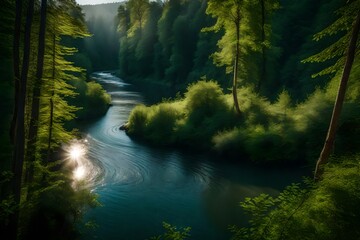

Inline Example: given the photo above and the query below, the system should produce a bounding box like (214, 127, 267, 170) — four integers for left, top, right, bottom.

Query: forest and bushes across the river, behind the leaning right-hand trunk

(118, 1, 359, 164)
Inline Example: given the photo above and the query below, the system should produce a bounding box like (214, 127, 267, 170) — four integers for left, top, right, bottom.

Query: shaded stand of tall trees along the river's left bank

(0, 0, 110, 239)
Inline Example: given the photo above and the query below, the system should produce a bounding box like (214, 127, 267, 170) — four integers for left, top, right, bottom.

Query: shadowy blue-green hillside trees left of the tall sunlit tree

(117, 0, 224, 87)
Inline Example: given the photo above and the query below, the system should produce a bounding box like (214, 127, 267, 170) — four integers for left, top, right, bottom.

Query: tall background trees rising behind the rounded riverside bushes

(116, 0, 354, 102)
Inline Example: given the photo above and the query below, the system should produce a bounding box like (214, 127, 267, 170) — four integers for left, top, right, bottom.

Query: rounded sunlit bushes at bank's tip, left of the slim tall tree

(128, 81, 234, 147)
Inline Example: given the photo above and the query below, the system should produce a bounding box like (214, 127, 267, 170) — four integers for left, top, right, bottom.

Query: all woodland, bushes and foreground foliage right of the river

(118, 0, 360, 239)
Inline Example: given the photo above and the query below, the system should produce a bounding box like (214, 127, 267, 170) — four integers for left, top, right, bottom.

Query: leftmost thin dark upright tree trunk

(10, 0, 22, 144)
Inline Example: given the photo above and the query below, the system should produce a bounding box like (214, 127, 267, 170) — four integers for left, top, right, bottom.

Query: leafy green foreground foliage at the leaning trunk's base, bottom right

(232, 155, 360, 239)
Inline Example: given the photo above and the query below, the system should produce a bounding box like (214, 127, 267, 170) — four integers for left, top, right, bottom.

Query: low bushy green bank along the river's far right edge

(126, 81, 359, 165)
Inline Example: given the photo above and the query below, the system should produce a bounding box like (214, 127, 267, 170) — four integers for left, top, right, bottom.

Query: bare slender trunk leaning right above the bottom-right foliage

(314, 12, 360, 180)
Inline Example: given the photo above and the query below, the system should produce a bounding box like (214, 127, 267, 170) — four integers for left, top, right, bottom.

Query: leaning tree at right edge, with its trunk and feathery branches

(305, 1, 360, 179)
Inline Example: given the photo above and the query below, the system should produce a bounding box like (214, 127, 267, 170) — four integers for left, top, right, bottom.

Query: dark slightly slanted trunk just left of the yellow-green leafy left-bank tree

(28, 0, 47, 182)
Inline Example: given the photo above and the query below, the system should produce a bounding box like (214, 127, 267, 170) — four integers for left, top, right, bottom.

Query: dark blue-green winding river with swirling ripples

(83, 72, 308, 240)
